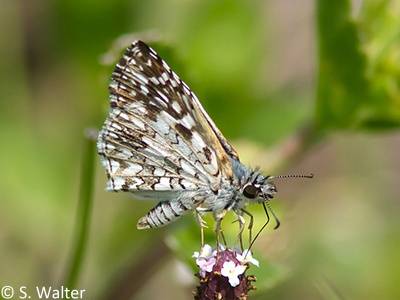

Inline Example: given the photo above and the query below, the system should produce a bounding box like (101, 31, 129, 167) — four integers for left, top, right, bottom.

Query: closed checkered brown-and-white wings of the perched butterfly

(98, 41, 237, 192)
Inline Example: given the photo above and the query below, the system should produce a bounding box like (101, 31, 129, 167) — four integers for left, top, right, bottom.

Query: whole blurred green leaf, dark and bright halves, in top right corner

(316, 0, 400, 129)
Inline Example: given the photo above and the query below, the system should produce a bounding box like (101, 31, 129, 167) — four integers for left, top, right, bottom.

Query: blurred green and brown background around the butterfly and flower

(0, 0, 400, 299)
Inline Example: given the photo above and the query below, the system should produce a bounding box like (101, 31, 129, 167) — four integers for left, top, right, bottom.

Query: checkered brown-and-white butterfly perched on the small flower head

(97, 41, 310, 246)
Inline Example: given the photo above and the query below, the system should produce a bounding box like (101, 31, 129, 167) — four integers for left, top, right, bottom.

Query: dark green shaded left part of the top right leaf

(316, 0, 369, 127)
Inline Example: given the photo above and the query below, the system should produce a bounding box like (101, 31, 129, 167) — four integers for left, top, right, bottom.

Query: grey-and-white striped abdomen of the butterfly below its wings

(136, 201, 190, 229)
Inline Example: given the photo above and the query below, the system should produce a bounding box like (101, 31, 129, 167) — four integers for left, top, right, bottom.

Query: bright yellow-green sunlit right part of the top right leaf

(359, 0, 400, 128)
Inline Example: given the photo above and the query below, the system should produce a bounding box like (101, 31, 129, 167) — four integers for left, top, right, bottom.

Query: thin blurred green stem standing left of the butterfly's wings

(64, 132, 96, 288)
